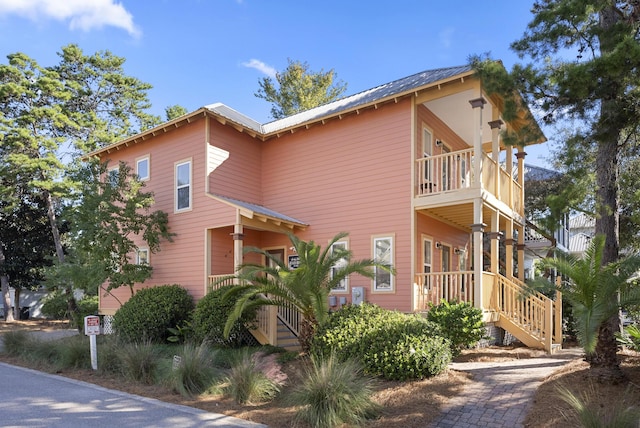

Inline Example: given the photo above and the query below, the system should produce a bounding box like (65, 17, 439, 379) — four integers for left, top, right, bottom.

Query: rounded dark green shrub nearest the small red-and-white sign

(113, 285, 194, 343)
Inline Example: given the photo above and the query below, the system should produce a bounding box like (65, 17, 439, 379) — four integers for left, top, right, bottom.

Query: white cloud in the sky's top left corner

(0, 0, 141, 37)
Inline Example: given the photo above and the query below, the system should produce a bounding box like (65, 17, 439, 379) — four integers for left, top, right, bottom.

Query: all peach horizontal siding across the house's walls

(101, 98, 496, 311)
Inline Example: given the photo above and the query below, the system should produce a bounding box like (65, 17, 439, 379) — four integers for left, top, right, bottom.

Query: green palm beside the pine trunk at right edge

(545, 235, 640, 368)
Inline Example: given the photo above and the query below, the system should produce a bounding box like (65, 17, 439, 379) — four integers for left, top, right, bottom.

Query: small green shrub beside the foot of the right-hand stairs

(427, 301, 486, 356)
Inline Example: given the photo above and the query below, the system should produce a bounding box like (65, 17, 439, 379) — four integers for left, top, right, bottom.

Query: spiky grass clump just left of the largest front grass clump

(224, 349, 280, 404)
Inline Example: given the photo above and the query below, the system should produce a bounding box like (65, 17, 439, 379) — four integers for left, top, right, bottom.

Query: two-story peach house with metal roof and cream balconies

(94, 66, 560, 350)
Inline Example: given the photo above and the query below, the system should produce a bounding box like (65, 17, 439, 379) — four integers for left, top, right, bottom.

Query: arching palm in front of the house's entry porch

(220, 232, 390, 351)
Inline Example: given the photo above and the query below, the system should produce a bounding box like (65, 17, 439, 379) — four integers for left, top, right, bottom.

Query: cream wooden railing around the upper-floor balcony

(415, 149, 524, 215)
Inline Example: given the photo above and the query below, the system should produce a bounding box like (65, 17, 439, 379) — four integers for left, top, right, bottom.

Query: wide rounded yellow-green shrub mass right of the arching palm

(311, 304, 451, 380)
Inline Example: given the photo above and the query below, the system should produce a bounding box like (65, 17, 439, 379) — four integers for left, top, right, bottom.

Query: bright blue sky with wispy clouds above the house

(0, 0, 552, 166)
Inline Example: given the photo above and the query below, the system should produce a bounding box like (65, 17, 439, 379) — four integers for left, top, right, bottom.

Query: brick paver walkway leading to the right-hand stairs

(430, 348, 583, 428)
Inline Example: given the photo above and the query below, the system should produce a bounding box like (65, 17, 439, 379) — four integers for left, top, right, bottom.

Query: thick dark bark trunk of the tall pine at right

(589, 5, 623, 380)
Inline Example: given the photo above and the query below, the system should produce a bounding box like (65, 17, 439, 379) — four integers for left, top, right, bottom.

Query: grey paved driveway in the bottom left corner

(0, 363, 265, 428)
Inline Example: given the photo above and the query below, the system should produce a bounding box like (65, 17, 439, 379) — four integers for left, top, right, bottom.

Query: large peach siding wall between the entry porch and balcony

(262, 100, 413, 311)
